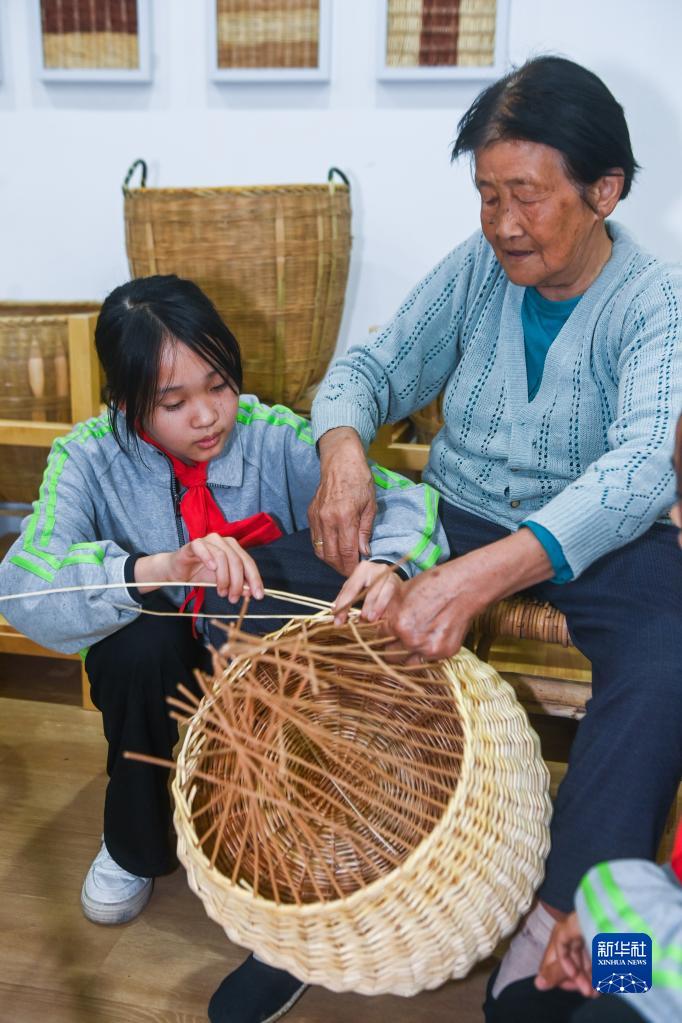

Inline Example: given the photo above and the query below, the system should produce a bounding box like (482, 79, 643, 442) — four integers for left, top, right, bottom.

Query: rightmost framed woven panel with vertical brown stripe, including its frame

(378, 0, 508, 81)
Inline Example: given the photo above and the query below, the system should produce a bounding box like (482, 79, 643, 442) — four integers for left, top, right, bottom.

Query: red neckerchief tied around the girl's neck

(138, 430, 284, 635)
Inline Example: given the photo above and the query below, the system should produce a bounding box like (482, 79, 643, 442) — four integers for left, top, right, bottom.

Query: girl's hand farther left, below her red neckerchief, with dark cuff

(135, 533, 264, 604)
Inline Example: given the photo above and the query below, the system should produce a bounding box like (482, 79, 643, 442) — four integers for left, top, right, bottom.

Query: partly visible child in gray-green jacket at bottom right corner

(484, 416, 682, 1023)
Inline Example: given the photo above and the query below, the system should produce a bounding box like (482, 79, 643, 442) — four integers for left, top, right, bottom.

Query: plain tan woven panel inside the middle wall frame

(216, 0, 320, 69)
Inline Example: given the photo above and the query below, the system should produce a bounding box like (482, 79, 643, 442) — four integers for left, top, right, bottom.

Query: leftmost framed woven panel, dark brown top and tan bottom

(35, 0, 151, 82)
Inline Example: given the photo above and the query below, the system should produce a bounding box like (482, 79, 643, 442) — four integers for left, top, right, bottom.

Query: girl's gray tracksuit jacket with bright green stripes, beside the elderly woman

(0, 395, 449, 653)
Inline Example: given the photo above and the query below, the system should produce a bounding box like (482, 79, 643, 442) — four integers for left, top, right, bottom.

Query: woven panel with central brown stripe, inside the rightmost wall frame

(385, 0, 497, 68)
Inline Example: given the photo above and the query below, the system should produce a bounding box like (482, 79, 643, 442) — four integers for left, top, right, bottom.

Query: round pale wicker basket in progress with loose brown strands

(173, 618, 550, 995)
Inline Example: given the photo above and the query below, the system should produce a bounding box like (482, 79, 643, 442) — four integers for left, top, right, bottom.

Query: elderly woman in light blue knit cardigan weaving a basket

(309, 57, 682, 1018)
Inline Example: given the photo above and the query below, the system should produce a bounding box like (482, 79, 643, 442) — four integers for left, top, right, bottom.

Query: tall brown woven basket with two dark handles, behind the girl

(124, 161, 351, 406)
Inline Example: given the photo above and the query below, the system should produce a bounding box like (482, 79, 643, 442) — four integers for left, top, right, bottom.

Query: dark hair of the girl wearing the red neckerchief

(95, 274, 241, 447)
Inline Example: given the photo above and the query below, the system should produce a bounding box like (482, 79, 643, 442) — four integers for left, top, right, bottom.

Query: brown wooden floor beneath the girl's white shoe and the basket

(0, 655, 494, 1023)
